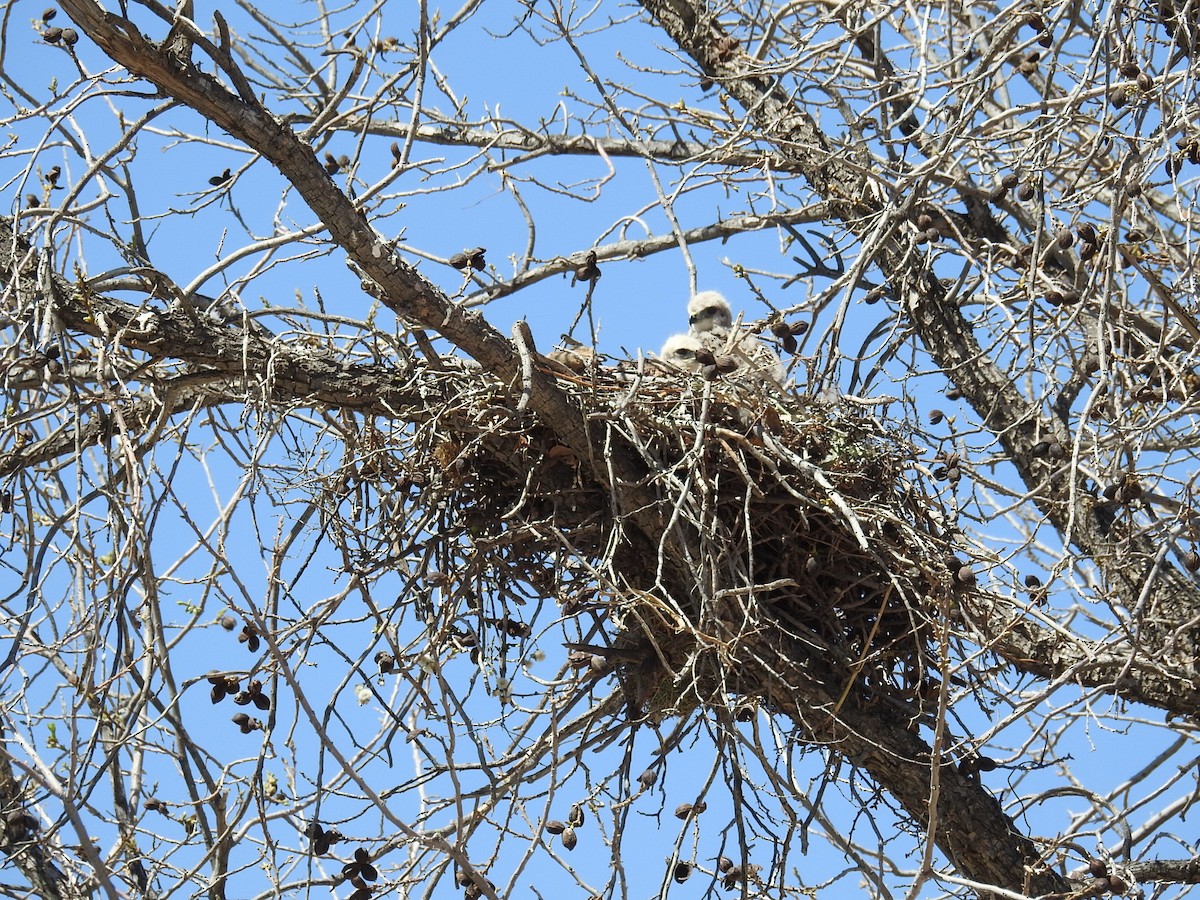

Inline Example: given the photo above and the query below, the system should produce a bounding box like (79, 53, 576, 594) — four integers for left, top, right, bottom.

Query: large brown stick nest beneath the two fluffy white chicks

(330, 357, 973, 719)
